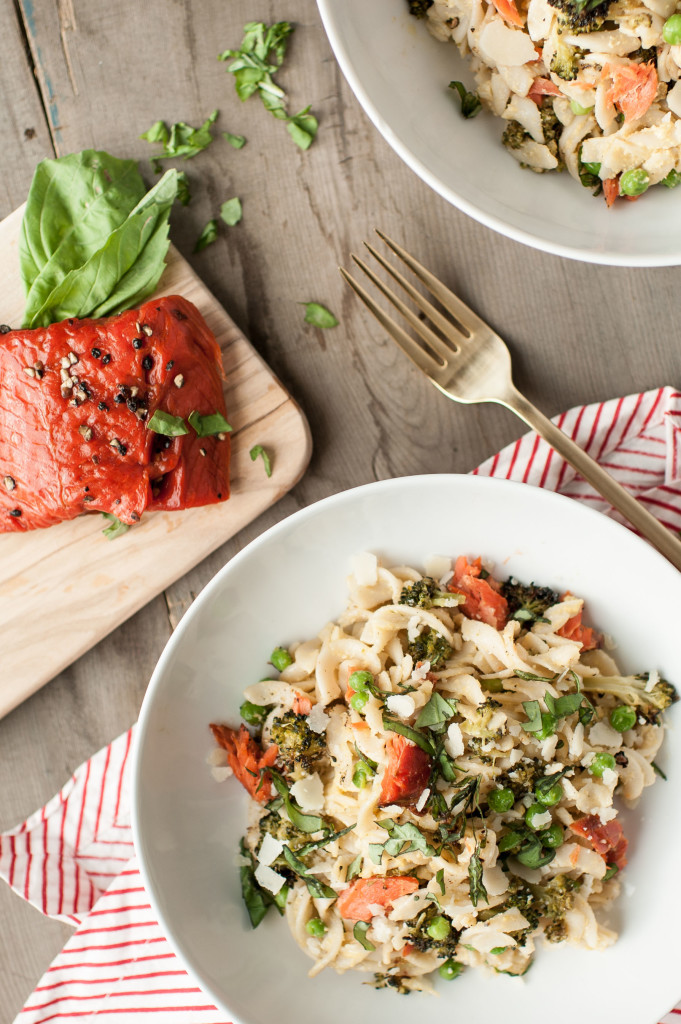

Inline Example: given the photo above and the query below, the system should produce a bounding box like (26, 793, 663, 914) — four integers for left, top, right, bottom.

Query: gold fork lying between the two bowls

(340, 229, 681, 569)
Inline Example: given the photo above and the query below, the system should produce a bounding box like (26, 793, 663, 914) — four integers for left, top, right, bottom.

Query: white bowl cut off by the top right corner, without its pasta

(317, 0, 681, 266)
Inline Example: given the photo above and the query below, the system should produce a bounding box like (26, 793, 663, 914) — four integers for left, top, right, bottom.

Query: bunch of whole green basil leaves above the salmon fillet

(19, 151, 178, 327)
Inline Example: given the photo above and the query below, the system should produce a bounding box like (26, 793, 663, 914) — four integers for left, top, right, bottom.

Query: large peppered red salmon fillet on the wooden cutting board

(0, 296, 229, 532)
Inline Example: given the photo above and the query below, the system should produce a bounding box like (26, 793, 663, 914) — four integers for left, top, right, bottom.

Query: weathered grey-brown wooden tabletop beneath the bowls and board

(0, 0, 681, 1011)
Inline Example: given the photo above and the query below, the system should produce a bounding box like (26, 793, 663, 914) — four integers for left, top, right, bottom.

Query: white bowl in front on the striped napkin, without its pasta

(133, 476, 681, 1024)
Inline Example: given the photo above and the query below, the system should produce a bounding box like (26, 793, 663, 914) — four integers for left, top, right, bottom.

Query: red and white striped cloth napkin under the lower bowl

(0, 387, 681, 1024)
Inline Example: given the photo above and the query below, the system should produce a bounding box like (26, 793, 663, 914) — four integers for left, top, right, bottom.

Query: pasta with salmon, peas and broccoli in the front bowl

(209, 553, 676, 992)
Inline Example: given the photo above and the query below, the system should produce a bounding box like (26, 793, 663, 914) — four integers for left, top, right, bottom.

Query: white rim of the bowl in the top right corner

(316, 0, 681, 267)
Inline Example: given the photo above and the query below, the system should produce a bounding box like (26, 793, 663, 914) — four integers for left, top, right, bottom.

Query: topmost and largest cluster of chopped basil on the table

(219, 22, 317, 150)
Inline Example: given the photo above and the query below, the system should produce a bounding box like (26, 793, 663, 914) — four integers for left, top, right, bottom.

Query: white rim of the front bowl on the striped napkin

(130, 473, 676, 1024)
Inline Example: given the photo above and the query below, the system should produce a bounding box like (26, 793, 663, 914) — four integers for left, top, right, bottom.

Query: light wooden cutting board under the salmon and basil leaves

(0, 207, 311, 717)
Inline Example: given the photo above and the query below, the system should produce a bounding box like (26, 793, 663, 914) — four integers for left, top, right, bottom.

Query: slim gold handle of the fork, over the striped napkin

(496, 387, 681, 570)
